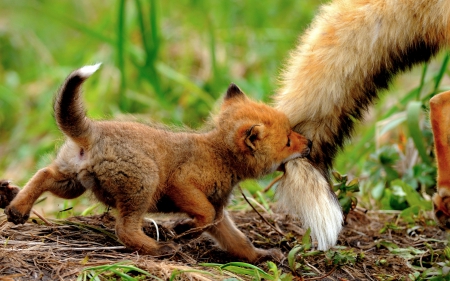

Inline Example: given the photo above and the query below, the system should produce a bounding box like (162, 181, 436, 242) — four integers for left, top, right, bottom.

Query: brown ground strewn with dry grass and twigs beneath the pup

(0, 205, 446, 281)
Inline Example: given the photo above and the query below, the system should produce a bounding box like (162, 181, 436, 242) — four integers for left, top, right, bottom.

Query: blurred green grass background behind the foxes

(0, 0, 450, 215)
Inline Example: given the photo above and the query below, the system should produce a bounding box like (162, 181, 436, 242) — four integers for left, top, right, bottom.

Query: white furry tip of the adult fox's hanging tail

(277, 159, 344, 251)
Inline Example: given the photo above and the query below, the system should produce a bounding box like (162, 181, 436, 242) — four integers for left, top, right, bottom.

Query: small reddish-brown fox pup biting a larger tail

(0, 64, 311, 262)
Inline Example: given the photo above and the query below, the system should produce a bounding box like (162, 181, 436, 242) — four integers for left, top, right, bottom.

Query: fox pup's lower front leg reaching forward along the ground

(207, 211, 283, 262)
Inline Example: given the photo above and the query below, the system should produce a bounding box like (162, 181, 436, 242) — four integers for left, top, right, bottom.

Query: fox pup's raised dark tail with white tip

(53, 63, 100, 147)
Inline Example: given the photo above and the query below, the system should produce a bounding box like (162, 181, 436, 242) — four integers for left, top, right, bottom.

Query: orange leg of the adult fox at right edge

(430, 91, 450, 229)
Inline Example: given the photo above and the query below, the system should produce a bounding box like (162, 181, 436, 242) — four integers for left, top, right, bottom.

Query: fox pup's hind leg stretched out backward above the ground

(5, 164, 86, 224)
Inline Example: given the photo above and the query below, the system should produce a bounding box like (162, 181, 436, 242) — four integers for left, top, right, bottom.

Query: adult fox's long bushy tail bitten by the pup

(275, 0, 450, 250)
